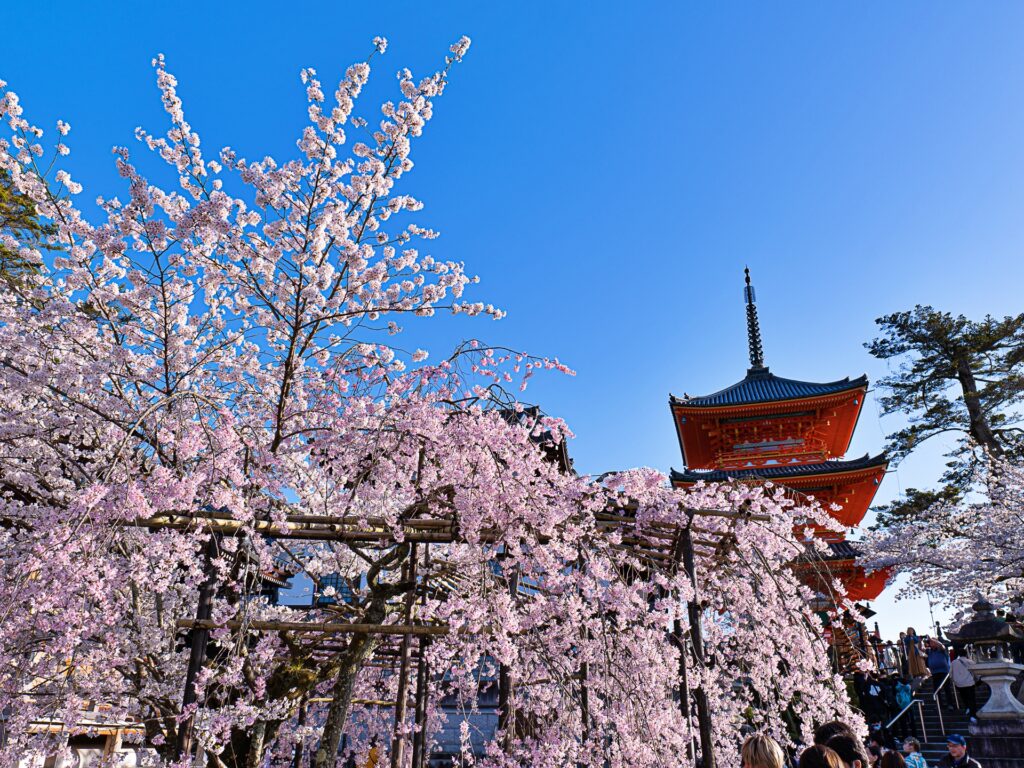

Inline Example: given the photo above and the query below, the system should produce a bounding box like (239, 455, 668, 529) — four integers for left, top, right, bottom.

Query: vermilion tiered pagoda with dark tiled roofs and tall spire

(669, 269, 889, 600)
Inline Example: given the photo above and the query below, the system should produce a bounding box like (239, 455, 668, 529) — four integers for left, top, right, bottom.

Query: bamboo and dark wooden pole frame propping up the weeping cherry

(153, 505, 769, 768)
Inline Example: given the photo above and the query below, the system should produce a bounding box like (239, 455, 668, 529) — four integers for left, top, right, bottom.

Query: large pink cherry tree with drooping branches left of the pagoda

(0, 38, 856, 768)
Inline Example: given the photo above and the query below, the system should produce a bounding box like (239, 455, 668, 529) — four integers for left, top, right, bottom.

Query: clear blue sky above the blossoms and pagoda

(8, 2, 1024, 633)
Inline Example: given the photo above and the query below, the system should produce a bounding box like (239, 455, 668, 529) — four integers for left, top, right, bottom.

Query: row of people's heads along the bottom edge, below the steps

(740, 720, 982, 768)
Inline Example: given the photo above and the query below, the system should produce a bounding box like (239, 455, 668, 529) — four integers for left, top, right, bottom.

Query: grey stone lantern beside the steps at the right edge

(949, 598, 1024, 768)
